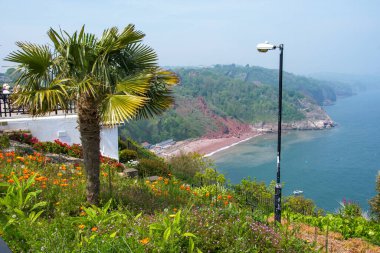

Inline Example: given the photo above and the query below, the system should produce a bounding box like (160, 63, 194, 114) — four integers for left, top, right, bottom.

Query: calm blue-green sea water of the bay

(211, 90, 380, 211)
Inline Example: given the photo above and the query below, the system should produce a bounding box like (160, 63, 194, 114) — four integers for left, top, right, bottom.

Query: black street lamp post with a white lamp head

(257, 41, 284, 223)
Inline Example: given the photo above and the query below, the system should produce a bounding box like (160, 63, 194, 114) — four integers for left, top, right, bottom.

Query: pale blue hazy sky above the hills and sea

(0, 0, 380, 74)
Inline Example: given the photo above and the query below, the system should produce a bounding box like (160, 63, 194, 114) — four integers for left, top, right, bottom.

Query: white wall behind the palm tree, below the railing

(0, 115, 119, 159)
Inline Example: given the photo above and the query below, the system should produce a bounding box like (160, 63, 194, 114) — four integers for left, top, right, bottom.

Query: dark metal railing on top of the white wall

(0, 94, 76, 118)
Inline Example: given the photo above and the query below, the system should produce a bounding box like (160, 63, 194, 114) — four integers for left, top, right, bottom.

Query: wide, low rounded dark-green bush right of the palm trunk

(136, 159, 170, 177)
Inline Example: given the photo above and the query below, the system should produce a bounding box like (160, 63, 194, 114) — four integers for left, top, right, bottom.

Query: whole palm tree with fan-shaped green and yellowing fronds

(5, 25, 179, 204)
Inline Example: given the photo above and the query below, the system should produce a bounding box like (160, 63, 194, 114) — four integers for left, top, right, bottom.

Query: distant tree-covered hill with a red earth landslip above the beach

(120, 65, 352, 143)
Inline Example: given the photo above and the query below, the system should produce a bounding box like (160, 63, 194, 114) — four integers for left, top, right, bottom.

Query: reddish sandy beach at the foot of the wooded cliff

(159, 130, 263, 157)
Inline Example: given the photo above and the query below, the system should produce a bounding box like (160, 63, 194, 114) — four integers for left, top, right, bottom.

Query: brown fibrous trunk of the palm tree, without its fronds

(78, 96, 100, 205)
